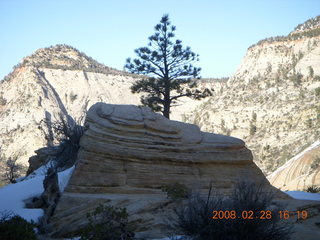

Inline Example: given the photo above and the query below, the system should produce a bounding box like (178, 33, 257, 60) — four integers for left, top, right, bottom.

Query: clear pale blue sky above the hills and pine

(0, 0, 320, 79)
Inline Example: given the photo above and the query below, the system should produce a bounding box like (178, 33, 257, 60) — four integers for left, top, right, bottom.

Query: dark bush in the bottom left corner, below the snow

(0, 213, 37, 240)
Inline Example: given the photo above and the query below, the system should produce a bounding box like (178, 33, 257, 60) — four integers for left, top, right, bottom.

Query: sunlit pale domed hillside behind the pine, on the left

(0, 45, 219, 169)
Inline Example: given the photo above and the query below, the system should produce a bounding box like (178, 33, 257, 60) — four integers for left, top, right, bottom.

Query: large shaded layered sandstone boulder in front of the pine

(51, 103, 282, 239)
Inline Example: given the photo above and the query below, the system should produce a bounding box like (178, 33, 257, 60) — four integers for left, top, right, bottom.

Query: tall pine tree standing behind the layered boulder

(125, 15, 212, 118)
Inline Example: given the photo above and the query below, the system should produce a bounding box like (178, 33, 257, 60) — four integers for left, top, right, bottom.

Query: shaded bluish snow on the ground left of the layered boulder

(0, 166, 74, 222)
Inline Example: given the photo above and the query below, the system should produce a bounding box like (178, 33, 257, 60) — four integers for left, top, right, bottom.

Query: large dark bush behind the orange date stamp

(168, 182, 292, 240)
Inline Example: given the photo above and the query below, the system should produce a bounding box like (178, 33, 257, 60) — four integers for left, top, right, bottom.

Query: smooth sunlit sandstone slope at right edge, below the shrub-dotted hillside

(268, 141, 320, 191)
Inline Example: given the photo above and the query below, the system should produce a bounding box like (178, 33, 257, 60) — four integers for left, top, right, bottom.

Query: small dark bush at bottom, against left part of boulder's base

(81, 204, 134, 240)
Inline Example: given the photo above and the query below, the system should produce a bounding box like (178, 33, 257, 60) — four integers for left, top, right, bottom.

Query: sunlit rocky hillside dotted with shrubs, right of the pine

(185, 16, 320, 173)
